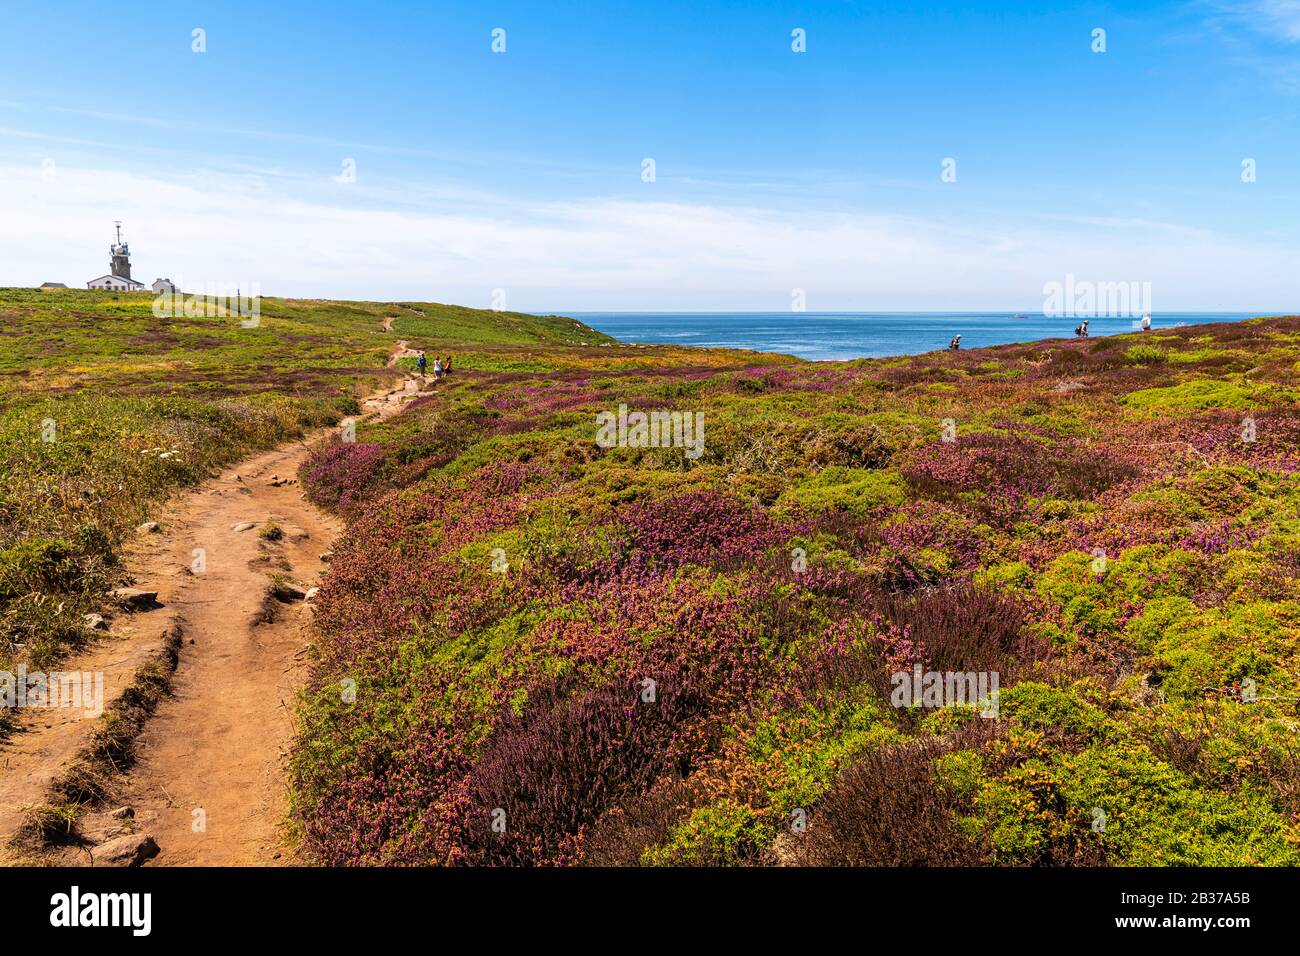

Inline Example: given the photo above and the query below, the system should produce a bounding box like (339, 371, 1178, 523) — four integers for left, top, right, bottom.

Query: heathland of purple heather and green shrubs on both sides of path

(0, 291, 1300, 865)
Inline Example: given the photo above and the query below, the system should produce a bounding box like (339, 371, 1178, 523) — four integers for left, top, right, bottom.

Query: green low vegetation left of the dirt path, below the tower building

(0, 289, 608, 676)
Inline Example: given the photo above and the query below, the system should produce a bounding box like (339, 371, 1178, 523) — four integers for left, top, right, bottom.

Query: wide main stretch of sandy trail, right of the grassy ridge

(83, 445, 341, 865)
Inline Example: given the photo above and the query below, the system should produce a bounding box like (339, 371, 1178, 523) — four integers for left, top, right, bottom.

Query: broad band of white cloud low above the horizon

(0, 166, 1296, 311)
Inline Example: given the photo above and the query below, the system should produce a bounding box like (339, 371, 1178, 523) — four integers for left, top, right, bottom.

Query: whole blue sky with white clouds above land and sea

(0, 0, 1300, 311)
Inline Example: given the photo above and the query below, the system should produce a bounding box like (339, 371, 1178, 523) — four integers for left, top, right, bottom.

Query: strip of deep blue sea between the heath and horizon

(564, 312, 1268, 360)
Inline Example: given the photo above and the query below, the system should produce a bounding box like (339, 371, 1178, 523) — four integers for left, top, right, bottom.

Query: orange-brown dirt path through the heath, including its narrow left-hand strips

(0, 342, 423, 865)
